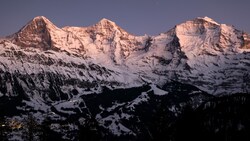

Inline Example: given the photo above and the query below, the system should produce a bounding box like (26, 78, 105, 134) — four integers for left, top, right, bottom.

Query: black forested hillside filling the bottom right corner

(172, 94, 250, 141)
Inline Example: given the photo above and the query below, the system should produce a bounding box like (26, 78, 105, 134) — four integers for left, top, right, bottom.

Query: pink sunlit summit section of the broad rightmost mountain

(174, 17, 248, 52)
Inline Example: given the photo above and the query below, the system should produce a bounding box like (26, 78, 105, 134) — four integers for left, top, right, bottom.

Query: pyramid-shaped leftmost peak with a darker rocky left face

(11, 16, 83, 53)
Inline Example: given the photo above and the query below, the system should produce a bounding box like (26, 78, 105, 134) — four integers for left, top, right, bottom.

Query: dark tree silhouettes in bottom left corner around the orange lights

(0, 114, 61, 141)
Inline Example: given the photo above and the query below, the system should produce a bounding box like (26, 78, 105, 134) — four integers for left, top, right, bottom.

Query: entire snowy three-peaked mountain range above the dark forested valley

(1, 16, 250, 94)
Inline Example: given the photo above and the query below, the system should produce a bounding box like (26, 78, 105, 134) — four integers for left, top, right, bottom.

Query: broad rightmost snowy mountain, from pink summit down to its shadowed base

(164, 17, 249, 94)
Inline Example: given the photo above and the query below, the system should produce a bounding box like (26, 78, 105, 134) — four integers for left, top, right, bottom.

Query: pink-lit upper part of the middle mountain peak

(63, 19, 148, 65)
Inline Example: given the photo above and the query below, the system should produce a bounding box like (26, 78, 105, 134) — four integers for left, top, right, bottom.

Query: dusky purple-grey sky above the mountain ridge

(0, 0, 250, 37)
